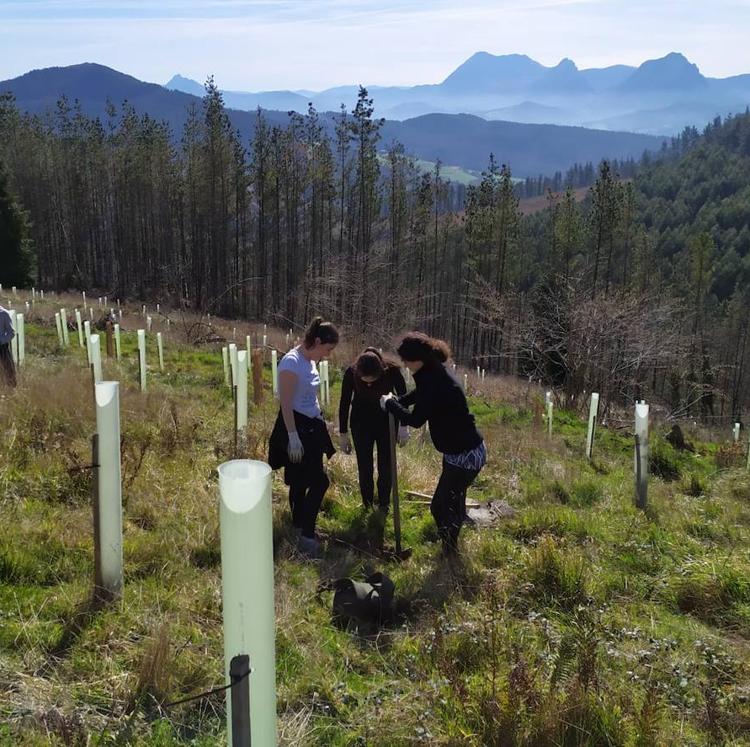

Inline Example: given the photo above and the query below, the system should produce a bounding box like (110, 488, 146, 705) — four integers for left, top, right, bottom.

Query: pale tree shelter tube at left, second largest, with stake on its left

(95, 381, 123, 596)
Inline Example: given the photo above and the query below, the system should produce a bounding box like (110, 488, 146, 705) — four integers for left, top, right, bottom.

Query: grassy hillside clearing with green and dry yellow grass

(0, 296, 750, 747)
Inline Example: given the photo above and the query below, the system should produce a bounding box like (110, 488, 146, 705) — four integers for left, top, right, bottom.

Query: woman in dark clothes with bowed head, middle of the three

(339, 348, 409, 512)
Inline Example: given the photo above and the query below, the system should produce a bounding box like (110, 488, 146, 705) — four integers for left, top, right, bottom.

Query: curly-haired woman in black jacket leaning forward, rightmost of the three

(380, 332, 487, 555)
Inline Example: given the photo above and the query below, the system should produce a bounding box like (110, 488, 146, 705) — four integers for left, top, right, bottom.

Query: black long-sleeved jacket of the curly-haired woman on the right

(386, 364, 482, 454)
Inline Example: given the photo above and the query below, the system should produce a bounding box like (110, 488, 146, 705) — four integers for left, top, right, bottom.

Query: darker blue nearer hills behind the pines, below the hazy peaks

(0, 63, 663, 177)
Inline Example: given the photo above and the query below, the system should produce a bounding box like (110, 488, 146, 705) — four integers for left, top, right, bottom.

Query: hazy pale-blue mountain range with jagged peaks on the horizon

(165, 52, 750, 135)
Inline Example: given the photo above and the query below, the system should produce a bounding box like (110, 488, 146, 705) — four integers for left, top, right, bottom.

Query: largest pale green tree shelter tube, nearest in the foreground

(219, 459, 277, 747)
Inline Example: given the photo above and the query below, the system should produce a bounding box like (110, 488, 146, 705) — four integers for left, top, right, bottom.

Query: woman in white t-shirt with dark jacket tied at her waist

(268, 317, 339, 557)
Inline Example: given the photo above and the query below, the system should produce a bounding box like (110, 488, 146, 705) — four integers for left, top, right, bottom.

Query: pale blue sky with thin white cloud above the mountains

(0, 0, 750, 91)
